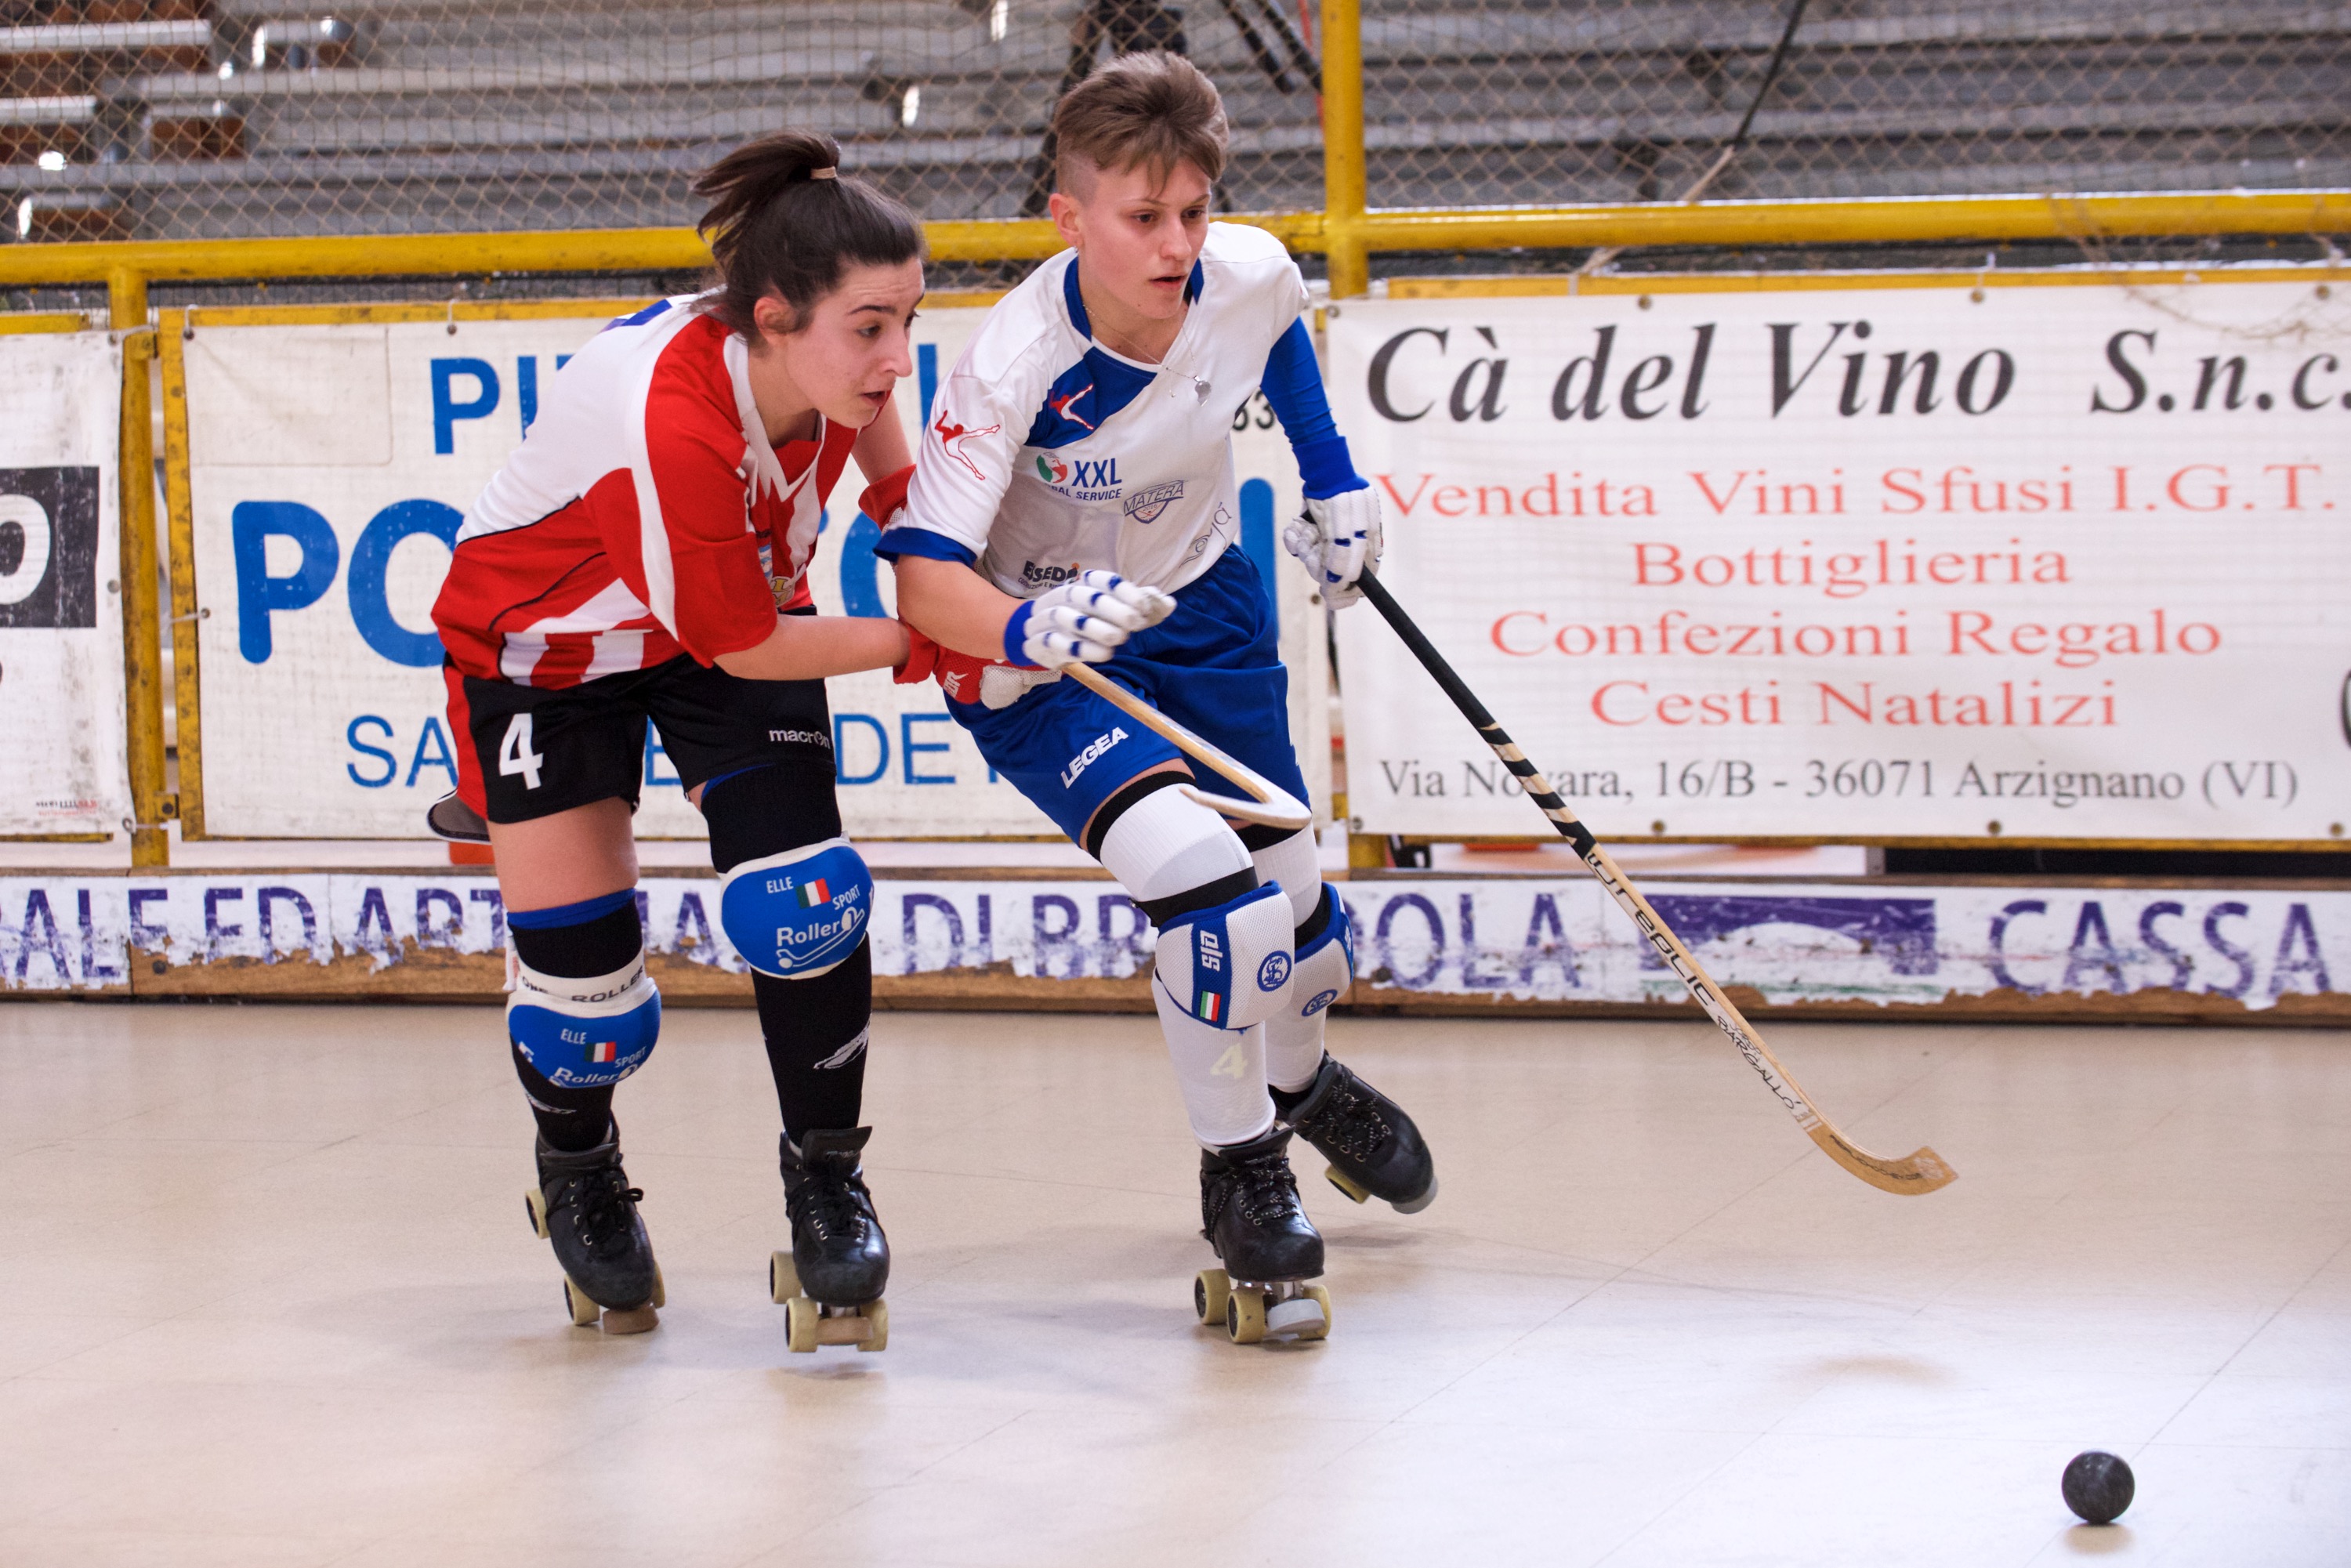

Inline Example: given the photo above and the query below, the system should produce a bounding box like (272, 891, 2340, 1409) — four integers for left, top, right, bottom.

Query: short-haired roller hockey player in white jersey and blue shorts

(872, 54, 1436, 1342)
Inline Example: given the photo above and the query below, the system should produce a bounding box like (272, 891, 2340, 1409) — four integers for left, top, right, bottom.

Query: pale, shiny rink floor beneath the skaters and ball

(0, 1004, 2351, 1568)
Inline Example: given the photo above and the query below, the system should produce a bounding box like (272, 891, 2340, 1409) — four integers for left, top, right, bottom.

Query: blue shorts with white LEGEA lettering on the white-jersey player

(947, 550, 1307, 844)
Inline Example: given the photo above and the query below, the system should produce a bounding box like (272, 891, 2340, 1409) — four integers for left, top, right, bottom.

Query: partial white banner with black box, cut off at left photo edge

(0, 331, 129, 837)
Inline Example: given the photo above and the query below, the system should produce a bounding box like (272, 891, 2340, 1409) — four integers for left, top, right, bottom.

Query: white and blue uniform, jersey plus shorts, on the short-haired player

(875, 223, 1364, 851)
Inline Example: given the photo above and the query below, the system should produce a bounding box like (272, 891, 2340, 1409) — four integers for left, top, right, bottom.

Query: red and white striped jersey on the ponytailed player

(433, 296, 858, 686)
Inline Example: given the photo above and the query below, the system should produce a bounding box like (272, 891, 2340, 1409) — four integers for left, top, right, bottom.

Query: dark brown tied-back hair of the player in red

(694, 132, 926, 341)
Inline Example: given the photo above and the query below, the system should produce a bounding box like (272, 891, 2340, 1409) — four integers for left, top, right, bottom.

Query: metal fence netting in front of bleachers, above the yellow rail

(0, 0, 2351, 240)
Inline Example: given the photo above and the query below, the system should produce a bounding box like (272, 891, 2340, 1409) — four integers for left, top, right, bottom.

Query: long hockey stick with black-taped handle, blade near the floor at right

(1359, 571, 1958, 1197)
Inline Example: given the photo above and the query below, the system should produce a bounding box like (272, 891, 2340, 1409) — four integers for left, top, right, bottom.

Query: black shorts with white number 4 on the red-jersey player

(442, 654, 835, 823)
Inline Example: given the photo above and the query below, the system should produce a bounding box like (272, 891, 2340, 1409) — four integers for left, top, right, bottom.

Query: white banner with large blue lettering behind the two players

(183, 308, 1328, 839)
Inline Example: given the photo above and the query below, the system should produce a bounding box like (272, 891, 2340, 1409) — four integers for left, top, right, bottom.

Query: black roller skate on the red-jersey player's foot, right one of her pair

(766, 1126, 889, 1352)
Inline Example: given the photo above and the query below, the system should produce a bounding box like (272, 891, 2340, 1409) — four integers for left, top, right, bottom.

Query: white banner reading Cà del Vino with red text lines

(1328, 278, 2351, 842)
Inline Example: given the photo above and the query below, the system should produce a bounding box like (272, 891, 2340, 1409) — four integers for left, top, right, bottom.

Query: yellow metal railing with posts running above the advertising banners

(0, 0, 2351, 865)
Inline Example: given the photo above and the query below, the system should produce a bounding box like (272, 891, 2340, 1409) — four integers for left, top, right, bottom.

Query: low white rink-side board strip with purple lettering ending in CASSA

(0, 870, 2351, 1011)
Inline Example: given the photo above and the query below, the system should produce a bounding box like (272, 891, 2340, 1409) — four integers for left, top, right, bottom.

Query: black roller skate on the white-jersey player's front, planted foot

(1192, 1124, 1331, 1345)
